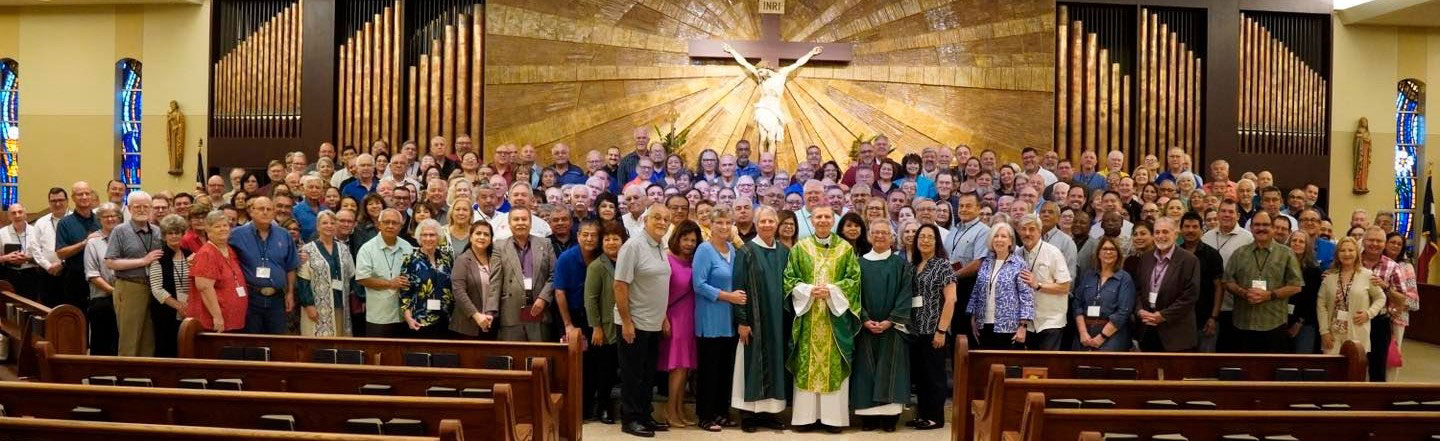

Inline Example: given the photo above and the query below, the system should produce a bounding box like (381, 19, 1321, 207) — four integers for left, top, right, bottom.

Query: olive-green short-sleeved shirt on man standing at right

(1225, 241, 1305, 331)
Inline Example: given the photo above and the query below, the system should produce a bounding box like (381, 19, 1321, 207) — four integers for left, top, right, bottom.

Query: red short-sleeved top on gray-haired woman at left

(186, 242, 249, 331)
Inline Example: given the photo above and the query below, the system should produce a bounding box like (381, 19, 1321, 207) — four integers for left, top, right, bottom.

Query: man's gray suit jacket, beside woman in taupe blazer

(491, 235, 554, 326)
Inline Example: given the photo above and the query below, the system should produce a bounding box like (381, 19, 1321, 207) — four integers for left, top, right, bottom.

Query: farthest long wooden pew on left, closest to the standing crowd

(179, 319, 583, 441)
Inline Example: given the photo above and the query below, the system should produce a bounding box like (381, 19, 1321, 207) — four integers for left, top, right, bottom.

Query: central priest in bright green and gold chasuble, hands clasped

(785, 205, 861, 432)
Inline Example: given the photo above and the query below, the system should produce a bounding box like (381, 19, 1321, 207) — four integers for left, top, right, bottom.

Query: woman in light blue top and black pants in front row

(691, 206, 746, 432)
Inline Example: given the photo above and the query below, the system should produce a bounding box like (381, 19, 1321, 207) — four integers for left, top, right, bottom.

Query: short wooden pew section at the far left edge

(0, 288, 89, 378)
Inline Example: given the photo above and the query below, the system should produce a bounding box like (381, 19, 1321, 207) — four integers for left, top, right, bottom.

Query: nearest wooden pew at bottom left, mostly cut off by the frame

(0, 417, 464, 441)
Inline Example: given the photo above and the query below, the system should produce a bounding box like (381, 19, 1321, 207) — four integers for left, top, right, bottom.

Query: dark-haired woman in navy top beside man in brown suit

(1070, 236, 1135, 352)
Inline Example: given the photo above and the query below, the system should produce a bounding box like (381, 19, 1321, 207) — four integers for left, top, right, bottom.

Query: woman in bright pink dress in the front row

(657, 221, 700, 427)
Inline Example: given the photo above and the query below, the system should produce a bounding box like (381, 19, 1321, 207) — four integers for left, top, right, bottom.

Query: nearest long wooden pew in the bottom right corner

(1004, 393, 1440, 441)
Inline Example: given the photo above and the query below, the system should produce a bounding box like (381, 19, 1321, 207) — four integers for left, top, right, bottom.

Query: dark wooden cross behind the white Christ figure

(690, 13, 854, 69)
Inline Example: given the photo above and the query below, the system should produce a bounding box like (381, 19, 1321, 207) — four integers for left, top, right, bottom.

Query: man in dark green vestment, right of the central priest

(850, 221, 914, 432)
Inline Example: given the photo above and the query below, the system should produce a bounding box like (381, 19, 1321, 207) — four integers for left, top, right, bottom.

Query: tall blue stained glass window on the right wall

(1395, 79, 1426, 238)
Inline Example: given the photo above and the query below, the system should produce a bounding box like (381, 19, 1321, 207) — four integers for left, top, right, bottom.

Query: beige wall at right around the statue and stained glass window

(1329, 20, 1440, 229)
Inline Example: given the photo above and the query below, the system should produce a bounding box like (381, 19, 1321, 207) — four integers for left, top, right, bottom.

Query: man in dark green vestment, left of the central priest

(730, 206, 792, 432)
